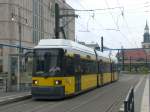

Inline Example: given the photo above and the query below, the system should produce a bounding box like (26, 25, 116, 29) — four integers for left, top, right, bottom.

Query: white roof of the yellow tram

(34, 39, 117, 60)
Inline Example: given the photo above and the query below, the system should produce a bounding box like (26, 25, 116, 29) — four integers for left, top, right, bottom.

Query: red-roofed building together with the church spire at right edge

(117, 21, 150, 72)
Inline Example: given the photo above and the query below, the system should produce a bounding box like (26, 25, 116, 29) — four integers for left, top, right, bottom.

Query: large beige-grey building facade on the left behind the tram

(0, 0, 75, 90)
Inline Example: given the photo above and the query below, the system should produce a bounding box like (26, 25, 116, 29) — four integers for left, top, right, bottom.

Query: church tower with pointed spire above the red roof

(142, 21, 150, 53)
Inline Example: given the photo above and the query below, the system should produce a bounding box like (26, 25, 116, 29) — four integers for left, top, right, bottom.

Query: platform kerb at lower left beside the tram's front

(0, 94, 32, 105)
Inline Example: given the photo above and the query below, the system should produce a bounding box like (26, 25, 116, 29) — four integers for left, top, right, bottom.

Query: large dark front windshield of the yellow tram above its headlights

(33, 49, 64, 77)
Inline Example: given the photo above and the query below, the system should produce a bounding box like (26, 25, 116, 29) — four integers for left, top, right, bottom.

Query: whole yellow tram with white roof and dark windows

(31, 39, 118, 99)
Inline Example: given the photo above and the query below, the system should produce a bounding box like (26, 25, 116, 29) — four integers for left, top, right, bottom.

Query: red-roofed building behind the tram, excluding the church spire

(117, 49, 150, 71)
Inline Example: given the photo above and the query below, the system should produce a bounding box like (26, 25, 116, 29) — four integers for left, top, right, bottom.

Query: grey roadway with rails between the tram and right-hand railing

(0, 74, 139, 112)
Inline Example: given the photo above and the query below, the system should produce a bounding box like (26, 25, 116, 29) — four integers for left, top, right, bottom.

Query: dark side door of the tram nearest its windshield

(74, 54, 81, 92)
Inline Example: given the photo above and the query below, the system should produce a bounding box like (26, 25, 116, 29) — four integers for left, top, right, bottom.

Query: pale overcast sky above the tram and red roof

(66, 0, 150, 48)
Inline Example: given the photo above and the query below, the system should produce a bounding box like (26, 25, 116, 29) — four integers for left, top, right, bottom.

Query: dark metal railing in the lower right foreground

(124, 87, 134, 112)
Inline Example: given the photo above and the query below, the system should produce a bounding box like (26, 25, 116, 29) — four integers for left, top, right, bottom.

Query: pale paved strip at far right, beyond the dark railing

(141, 77, 150, 112)
